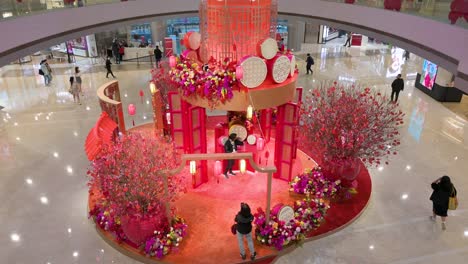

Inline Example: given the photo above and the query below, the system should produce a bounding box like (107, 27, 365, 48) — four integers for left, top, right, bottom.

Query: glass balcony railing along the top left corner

(0, 0, 135, 20)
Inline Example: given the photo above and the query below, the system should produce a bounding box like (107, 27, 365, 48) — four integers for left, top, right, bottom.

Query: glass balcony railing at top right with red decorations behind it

(322, 0, 468, 29)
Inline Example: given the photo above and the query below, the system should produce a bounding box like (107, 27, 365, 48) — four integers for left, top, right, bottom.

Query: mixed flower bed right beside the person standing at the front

(254, 198, 329, 250)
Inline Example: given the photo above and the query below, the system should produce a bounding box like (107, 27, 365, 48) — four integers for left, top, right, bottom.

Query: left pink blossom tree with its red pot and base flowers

(88, 133, 186, 256)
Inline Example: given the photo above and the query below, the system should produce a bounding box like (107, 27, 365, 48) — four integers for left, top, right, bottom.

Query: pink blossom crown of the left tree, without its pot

(88, 133, 185, 221)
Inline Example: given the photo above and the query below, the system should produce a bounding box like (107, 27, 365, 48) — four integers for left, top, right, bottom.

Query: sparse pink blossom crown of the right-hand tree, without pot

(300, 83, 404, 171)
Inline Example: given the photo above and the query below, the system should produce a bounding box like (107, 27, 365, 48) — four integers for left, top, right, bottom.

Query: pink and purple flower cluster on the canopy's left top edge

(169, 57, 237, 107)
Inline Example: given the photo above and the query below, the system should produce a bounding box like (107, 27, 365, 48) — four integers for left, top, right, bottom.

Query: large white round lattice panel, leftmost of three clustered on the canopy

(240, 56, 268, 88)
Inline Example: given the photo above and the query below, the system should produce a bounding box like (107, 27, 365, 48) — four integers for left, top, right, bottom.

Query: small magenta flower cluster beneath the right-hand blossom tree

(289, 167, 341, 199)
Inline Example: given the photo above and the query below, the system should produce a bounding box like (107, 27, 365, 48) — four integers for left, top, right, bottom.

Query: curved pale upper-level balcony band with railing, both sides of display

(0, 0, 468, 92)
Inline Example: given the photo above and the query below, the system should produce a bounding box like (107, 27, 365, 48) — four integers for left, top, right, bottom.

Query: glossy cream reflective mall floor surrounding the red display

(0, 45, 468, 264)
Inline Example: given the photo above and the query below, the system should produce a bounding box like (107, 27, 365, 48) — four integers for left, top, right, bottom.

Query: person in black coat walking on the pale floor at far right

(429, 176, 457, 230)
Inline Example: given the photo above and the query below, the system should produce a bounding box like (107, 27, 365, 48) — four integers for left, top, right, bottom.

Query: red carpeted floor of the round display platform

(90, 122, 371, 263)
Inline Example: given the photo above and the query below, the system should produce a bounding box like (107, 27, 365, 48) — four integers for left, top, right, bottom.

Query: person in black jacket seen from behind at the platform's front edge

(234, 203, 257, 260)
